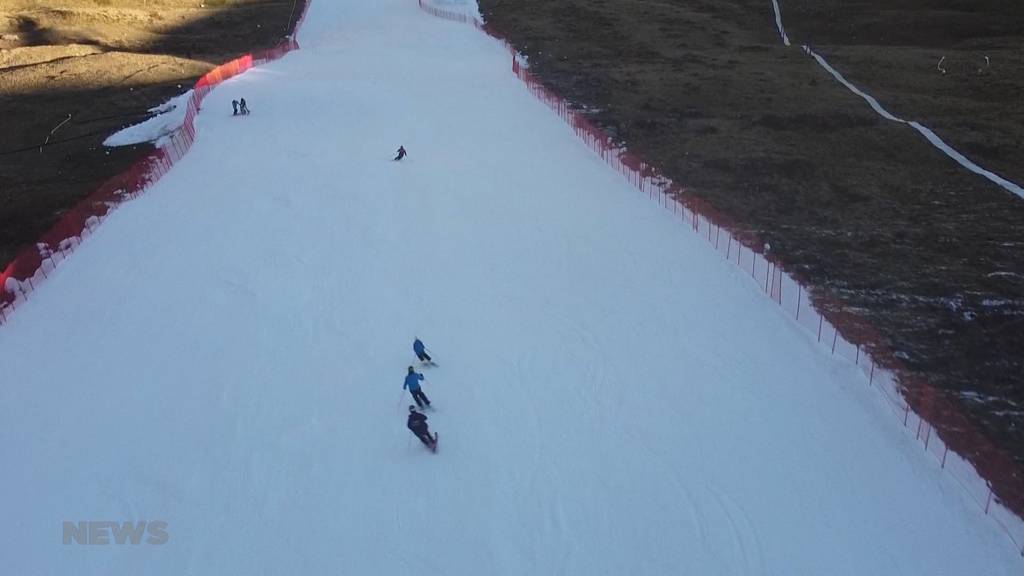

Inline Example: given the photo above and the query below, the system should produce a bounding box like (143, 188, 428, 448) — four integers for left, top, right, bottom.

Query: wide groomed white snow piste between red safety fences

(0, 0, 1022, 576)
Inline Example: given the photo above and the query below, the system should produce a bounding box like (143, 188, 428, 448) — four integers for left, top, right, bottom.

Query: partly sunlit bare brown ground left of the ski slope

(0, 0, 304, 266)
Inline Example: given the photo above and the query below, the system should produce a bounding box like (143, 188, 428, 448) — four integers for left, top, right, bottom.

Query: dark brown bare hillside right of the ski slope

(480, 0, 1024, 491)
